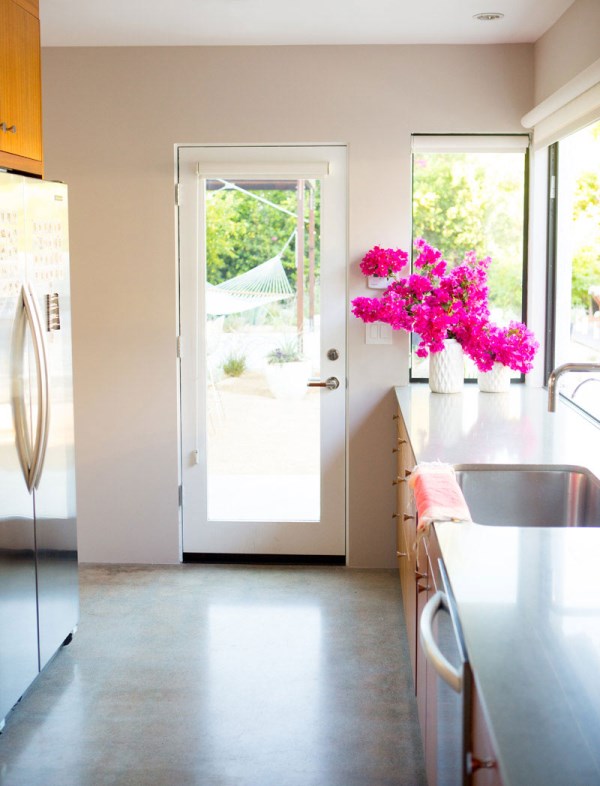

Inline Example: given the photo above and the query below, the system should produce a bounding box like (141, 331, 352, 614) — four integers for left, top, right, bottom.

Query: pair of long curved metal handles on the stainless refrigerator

(11, 285, 49, 492)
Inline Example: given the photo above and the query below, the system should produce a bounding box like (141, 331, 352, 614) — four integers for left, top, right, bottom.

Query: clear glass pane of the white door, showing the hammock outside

(204, 179, 320, 521)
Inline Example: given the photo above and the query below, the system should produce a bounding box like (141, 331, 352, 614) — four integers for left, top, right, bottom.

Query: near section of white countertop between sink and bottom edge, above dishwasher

(436, 523, 600, 786)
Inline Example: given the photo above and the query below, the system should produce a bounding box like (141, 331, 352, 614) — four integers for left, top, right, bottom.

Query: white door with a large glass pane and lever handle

(178, 146, 347, 556)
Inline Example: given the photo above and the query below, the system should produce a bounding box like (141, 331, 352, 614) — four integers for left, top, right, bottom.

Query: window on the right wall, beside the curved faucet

(546, 121, 600, 420)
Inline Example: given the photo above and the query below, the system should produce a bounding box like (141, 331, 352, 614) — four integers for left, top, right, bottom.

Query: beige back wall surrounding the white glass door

(43, 45, 533, 567)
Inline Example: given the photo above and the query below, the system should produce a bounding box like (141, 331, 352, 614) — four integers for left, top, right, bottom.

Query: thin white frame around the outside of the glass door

(175, 143, 349, 565)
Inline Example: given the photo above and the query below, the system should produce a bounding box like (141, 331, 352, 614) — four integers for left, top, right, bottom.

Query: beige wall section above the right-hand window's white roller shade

(534, 0, 600, 104)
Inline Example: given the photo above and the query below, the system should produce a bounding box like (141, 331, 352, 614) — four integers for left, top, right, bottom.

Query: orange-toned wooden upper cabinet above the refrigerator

(0, 0, 43, 175)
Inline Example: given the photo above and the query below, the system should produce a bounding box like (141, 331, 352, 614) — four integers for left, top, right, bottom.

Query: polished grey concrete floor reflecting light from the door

(0, 565, 432, 786)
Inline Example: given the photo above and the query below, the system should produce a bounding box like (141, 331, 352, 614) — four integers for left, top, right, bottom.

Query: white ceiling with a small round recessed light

(40, 0, 573, 46)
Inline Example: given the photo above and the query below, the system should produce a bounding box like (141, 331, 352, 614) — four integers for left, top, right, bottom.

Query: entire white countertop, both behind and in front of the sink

(396, 385, 600, 786)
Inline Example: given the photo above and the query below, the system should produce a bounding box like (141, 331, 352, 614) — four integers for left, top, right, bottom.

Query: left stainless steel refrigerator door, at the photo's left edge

(0, 174, 38, 723)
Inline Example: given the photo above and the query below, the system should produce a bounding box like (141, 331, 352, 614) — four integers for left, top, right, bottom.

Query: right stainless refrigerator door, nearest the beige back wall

(25, 180, 79, 668)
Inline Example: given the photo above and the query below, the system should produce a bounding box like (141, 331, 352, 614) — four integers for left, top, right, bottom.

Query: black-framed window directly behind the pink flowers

(411, 135, 529, 380)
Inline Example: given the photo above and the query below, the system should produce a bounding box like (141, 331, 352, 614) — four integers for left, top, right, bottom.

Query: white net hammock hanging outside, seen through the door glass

(206, 239, 295, 316)
